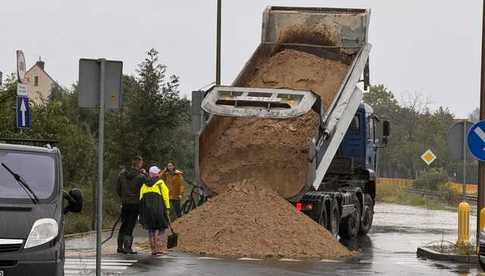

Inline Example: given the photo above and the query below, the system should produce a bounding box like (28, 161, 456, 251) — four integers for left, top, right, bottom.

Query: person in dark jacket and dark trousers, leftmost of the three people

(116, 156, 146, 254)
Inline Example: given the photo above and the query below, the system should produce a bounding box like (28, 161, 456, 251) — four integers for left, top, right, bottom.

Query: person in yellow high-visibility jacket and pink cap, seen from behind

(140, 166, 170, 255)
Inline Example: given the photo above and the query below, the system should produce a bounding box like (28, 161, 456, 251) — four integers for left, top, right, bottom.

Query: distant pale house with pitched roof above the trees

(25, 58, 59, 104)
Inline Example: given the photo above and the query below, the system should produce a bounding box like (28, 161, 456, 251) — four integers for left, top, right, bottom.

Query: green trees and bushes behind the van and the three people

(0, 49, 193, 232)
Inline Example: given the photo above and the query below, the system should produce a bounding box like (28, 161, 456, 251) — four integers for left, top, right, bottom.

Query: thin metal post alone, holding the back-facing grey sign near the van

(96, 59, 106, 276)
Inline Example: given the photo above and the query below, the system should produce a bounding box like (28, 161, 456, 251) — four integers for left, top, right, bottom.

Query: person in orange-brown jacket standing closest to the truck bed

(161, 162, 185, 218)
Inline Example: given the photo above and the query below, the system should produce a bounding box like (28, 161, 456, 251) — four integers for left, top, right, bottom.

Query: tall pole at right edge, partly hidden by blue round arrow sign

(477, 0, 485, 248)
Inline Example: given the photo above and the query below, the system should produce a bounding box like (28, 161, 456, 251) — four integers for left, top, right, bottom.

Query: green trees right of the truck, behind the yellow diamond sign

(364, 85, 460, 182)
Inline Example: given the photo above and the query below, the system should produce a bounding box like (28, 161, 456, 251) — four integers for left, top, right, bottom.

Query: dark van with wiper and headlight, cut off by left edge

(0, 142, 82, 276)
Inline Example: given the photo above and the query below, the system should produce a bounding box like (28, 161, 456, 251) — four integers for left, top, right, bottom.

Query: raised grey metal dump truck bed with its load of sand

(193, 7, 370, 201)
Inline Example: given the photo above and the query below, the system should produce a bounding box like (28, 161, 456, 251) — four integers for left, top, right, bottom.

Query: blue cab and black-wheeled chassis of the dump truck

(297, 103, 390, 239)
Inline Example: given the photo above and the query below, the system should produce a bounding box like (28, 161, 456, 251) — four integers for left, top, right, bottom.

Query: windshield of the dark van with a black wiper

(0, 150, 56, 201)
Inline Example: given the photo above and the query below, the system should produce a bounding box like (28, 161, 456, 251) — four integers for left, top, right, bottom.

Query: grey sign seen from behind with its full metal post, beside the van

(79, 58, 123, 276)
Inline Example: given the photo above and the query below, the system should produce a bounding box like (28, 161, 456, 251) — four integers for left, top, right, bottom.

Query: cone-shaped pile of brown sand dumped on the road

(173, 183, 351, 258)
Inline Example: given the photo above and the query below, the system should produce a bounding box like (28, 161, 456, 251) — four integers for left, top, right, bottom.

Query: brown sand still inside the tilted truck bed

(200, 49, 348, 198)
